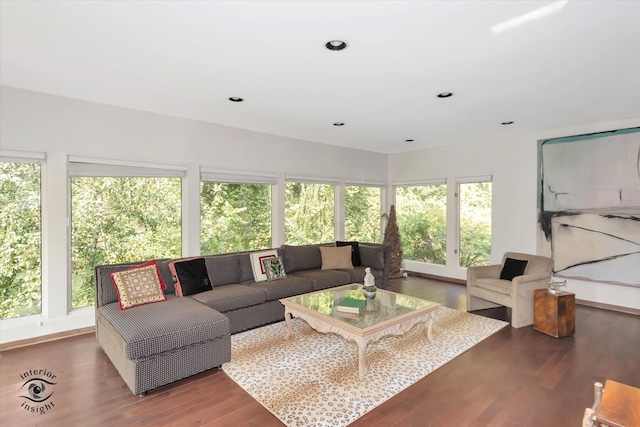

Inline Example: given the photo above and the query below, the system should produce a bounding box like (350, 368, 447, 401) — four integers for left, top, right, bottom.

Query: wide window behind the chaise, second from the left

(71, 164, 182, 308)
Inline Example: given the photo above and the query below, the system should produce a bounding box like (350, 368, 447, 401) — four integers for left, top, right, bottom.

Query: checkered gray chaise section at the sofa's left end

(96, 263, 231, 395)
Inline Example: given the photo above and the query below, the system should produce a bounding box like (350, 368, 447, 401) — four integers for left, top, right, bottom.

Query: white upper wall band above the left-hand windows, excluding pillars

(0, 86, 387, 182)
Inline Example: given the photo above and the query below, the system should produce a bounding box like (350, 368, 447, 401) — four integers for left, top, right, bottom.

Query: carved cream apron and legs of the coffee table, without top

(284, 307, 433, 381)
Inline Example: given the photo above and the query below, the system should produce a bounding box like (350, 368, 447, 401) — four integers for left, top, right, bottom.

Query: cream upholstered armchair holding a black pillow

(467, 252, 553, 328)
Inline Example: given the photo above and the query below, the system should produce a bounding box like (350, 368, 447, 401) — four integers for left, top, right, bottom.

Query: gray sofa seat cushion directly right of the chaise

(191, 284, 267, 313)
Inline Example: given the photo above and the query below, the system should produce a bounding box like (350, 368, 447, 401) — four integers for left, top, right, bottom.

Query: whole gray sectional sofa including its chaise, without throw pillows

(95, 243, 391, 395)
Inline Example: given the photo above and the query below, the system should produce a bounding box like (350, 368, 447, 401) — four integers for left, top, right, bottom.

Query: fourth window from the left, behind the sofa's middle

(285, 182, 335, 245)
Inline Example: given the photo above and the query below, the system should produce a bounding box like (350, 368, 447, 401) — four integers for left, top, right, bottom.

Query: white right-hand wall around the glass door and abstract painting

(389, 118, 640, 309)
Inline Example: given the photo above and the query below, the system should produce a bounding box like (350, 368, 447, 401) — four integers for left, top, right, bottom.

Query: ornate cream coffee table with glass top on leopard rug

(280, 283, 440, 380)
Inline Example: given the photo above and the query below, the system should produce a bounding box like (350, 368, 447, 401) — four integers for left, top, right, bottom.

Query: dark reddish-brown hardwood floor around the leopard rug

(0, 277, 640, 427)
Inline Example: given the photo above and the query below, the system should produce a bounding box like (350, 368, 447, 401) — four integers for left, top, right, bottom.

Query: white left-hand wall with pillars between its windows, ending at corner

(0, 86, 387, 343)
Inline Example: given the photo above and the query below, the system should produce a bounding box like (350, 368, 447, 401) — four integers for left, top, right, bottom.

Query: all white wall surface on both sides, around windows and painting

(0, 86, 640, 343)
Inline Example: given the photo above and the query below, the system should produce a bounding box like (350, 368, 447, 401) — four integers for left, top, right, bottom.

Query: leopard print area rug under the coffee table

(222, 307, 508, 427)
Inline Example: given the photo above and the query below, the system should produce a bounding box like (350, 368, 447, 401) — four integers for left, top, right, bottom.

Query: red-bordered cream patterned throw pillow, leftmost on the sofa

(111, 260, 166, 310)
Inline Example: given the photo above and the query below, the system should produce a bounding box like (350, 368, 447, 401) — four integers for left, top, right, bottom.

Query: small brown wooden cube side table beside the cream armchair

(533, 289, 576, 338)
